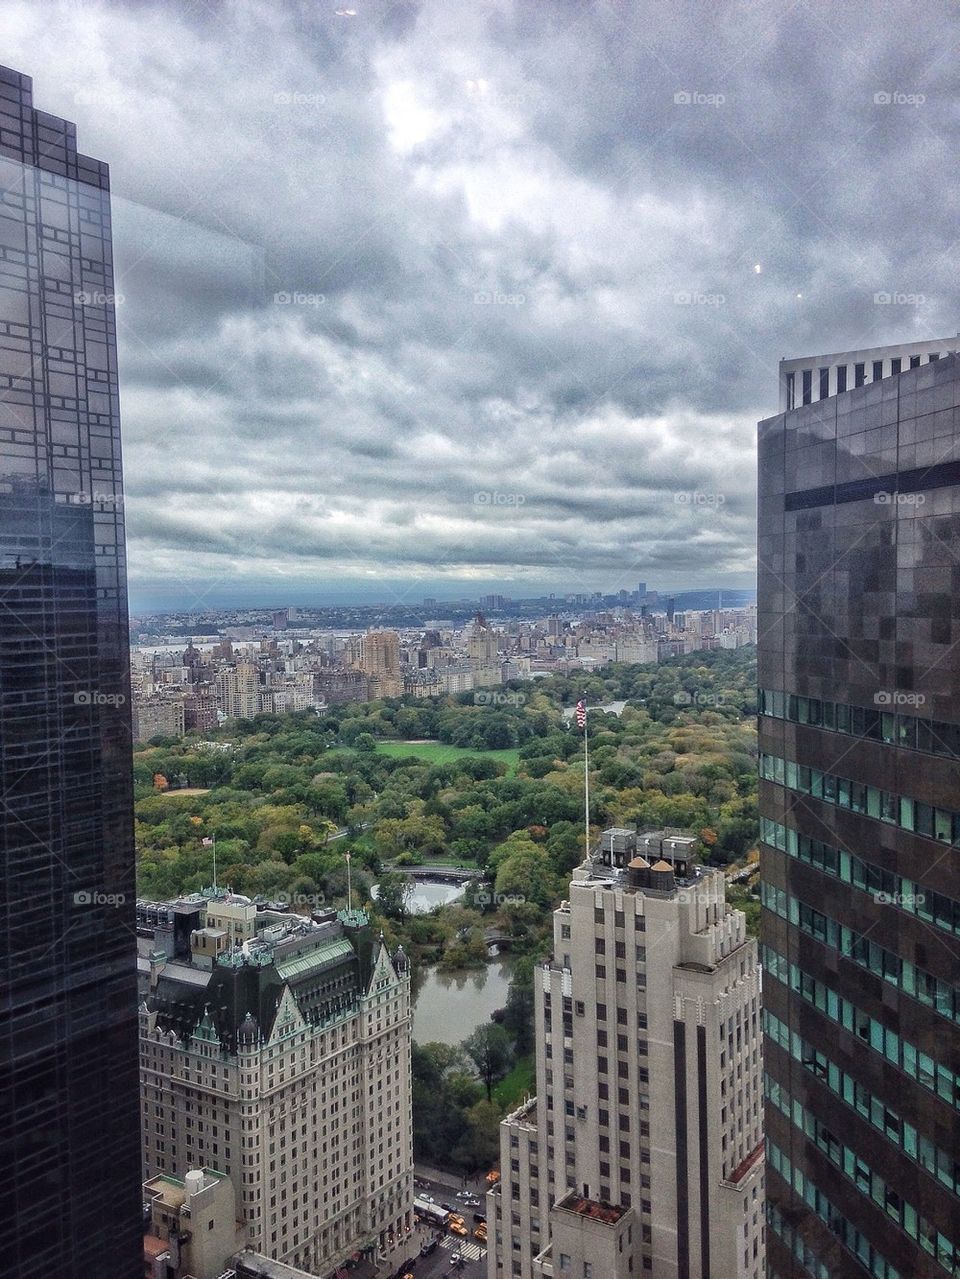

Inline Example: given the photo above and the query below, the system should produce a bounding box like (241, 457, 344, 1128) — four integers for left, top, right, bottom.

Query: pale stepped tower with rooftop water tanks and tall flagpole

(487, 829, 764, 1279)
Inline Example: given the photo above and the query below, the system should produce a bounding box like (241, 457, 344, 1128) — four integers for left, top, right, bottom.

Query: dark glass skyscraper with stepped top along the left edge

(0, 69, 143, 1279)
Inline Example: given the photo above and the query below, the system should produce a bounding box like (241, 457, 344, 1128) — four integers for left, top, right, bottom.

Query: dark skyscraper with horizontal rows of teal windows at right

(758, 339, 960, 1279)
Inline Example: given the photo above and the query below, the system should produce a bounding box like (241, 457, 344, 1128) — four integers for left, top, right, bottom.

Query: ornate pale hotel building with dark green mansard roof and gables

(138, 890, 413, 1275)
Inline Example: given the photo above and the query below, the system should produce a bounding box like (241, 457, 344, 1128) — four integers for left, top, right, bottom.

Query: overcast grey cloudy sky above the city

(0, 0, 960, 608)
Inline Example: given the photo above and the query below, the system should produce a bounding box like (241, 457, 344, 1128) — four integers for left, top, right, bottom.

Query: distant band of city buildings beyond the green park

(130, 583, 757, 742)
